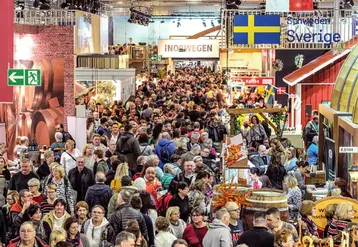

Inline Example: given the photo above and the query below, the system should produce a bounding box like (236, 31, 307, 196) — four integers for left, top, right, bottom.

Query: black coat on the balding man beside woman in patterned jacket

(68, 167, 95, 202)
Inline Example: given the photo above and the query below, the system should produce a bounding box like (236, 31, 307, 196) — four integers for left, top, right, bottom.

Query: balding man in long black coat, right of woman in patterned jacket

(68, 157, 95, 202)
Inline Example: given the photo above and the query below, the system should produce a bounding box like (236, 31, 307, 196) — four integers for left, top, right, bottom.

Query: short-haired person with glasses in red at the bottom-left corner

(8, 221, 49, 247)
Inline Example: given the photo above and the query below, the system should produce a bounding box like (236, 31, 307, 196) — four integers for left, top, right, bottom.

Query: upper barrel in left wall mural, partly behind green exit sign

(24, 59, 65, 112)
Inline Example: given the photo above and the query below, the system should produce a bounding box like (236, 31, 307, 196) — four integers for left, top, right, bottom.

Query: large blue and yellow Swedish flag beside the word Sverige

(233, 15, 281, 45)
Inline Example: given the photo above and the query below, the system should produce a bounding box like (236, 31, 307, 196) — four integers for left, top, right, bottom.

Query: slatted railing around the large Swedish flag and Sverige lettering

(220, 10, 358, 49)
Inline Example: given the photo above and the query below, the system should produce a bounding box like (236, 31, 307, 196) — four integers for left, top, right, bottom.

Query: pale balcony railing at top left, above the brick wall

(14, 10, 76, 26)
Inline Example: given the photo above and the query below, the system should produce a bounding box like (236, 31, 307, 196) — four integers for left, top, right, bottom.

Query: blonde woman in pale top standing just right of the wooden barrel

(284, 174, 302, 221)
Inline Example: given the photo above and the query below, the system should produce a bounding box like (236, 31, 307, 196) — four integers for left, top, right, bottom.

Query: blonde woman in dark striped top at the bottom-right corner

(328, 202, 354, 247)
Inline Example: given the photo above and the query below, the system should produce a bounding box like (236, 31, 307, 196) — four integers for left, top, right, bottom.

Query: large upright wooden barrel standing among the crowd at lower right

(241, 189, 288, 231)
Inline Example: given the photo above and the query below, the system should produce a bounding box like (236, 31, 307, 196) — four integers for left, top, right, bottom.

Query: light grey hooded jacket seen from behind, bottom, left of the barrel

(203, 219, 233, 247)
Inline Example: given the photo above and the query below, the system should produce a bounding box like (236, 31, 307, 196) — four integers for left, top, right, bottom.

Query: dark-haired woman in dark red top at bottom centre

(183, 207, 209, 247)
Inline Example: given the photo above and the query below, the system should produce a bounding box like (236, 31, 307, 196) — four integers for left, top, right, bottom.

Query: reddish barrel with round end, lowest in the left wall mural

(31, 107, 64, 147)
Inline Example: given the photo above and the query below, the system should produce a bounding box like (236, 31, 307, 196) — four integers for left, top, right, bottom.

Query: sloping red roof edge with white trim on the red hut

(283, 36, 358, 86)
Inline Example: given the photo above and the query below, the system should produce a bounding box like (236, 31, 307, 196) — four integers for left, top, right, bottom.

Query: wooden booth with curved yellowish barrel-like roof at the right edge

(319, 43, 358, 180)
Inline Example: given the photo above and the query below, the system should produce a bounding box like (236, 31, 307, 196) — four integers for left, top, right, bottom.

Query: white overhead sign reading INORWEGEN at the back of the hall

(158, 39, 219, 58)
